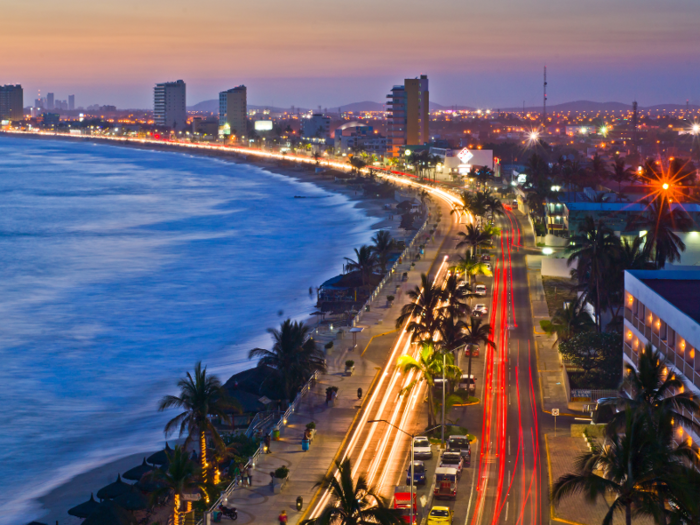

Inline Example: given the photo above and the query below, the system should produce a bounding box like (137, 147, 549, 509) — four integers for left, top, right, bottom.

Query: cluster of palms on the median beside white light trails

(396, 272, 495, 427)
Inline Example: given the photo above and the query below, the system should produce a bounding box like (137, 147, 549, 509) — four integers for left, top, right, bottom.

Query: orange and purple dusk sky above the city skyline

(0, 0, 700, 108)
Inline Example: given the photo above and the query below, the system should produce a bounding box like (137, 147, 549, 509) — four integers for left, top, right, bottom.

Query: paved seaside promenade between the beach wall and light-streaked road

(224, 201, 454, 525)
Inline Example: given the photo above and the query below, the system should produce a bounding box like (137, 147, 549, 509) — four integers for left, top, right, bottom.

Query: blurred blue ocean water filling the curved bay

(0, 136, 377, 525)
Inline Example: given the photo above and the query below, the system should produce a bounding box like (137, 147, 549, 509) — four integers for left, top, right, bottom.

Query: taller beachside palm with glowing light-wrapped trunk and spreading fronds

(158, 361, 239, 477)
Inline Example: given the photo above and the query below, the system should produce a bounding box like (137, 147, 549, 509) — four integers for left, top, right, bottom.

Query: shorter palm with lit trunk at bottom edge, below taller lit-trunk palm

(147, 445, 200, 525)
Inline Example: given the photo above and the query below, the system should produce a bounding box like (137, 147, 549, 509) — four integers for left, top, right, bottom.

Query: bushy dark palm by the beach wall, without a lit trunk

(248, 319, 326, 401)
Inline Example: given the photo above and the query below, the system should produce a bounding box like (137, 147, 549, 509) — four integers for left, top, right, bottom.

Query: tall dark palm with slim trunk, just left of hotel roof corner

(566, 216, 620, 332)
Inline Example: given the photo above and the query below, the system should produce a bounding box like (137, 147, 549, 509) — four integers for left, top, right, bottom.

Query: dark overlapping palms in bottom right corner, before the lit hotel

(552, 345, 700, 525)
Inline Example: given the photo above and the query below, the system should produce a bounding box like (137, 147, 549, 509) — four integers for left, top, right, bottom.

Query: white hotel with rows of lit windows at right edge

(623, 266, 700, 444)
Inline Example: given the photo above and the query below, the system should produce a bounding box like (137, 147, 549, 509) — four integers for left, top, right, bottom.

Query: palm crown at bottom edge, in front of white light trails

(301, 459, 403, 525)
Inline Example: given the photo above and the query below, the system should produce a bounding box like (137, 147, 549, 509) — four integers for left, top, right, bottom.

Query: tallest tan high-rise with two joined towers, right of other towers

(387, 75, 430, 157)
